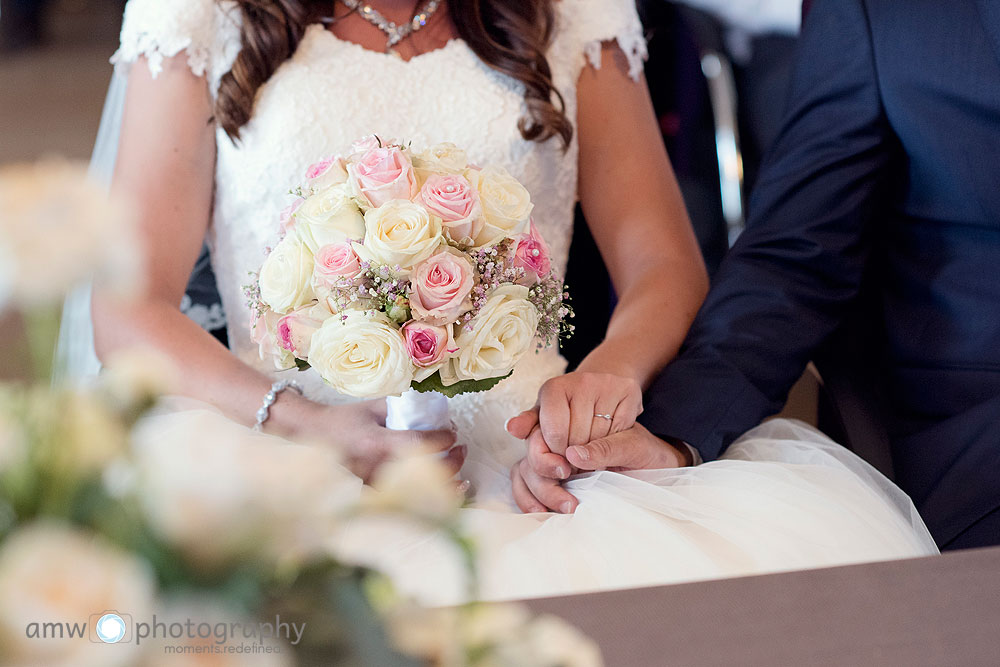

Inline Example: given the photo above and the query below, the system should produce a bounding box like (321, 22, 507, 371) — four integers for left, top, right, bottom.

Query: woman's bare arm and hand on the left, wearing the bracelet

(93, 54, 451, 478)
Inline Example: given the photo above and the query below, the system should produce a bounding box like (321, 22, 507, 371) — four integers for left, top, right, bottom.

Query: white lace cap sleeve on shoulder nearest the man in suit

(549, 0, 646, 78)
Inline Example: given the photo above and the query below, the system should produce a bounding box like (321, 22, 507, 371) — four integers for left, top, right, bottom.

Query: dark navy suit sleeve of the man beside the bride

(640, 0, 898, 460)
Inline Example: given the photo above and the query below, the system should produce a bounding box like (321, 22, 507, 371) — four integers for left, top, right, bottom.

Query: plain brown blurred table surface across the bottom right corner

(530, 547, 1000, 667)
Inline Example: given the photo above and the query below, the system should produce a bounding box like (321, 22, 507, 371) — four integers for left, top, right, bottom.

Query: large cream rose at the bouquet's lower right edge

(441, 285, 538, 385)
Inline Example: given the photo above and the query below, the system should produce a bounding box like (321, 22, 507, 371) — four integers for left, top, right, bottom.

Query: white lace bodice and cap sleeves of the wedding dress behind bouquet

(113, 0, 645, 408)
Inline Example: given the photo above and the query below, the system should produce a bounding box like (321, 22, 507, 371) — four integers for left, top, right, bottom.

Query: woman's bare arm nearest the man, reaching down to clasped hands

(507, 43, 708, 512)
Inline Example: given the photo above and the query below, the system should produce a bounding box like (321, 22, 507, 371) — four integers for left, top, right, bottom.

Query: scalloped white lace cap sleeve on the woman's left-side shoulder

(111, 0, 240, 94)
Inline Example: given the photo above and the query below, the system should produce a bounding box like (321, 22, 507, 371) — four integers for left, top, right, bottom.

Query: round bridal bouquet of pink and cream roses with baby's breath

(247, 136, 572, 428)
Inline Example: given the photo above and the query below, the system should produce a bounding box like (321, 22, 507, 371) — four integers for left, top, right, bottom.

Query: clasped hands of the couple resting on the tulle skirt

(507, 372, 689, 514)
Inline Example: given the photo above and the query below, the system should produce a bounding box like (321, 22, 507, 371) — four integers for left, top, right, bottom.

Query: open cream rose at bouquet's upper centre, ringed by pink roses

(354, 199, 445, 273)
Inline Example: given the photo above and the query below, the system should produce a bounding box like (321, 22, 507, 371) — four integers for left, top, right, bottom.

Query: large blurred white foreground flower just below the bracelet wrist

(134, 410, 361, 566)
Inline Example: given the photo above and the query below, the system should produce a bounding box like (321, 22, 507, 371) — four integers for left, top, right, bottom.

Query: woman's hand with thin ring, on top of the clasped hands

(538, 371, 642, 455)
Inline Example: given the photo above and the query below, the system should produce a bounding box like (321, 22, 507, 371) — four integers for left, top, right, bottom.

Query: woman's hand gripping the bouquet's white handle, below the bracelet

(297, 400, 468, 482)
